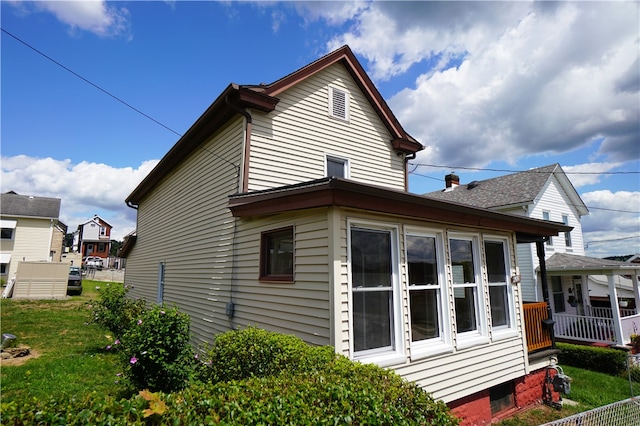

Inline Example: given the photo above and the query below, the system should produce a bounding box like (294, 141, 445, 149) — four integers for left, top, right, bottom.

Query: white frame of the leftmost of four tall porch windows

(347, 219, 406, 366)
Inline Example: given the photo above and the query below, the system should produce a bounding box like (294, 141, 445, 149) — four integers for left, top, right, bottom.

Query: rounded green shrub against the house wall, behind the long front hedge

(204, 327, 336, 383)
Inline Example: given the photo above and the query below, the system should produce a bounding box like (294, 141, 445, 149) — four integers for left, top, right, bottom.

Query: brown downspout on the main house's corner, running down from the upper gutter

(224, 94, 253, 322)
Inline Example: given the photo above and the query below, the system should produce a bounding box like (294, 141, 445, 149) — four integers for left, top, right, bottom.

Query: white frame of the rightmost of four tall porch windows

(482, 235, 518, 340)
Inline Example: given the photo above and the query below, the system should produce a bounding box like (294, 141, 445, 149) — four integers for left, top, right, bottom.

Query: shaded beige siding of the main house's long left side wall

(125, 116, 244, 344)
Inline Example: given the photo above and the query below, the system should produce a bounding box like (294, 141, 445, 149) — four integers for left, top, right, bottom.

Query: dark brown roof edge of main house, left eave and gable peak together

(125, 46, 423, 207)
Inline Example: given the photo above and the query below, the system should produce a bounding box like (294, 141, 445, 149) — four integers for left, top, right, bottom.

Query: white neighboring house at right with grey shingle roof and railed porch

(425, 164, 640, 344)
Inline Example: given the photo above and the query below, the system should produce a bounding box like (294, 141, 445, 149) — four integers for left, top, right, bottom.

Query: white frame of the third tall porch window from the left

(447, 232, 489, 349)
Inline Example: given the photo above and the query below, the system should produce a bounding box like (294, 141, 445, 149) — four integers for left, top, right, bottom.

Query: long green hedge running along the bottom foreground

(2, 357, 459, 425)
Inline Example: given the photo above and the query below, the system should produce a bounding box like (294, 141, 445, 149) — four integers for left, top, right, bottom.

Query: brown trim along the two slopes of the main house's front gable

(264, 45, 424, 154)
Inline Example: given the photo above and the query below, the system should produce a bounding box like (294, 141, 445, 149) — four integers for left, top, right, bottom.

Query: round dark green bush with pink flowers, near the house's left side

(120, 305, 196, 392)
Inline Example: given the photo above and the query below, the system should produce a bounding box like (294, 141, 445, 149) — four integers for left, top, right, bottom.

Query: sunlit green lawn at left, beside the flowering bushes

(0, 280, 121, 403)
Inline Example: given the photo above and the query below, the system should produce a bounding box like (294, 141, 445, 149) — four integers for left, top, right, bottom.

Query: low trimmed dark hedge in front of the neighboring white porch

(557, 343, 627, 376)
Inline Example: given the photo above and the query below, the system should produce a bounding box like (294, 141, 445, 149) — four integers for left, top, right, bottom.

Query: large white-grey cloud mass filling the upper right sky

(316, 2, 640, 171)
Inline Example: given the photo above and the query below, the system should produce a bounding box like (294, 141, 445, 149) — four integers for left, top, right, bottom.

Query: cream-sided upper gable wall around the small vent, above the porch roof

(248, 64, 405, 190)
